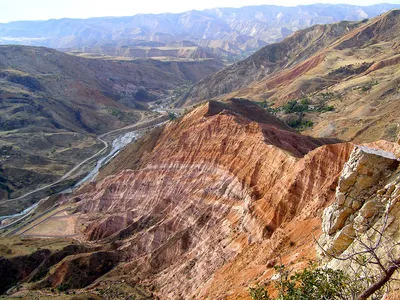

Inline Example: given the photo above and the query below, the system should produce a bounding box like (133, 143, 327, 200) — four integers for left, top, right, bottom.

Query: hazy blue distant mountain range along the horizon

(0, 4, 400, 62)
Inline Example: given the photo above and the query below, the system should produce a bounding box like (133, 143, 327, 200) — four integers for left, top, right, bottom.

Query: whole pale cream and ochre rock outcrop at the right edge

(316, 144, 400, 290)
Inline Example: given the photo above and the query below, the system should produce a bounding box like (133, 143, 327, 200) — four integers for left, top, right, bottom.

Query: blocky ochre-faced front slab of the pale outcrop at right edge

(317, 146, 400, 256)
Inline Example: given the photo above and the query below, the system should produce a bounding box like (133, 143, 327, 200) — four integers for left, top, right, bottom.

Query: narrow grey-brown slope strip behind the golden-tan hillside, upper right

(183, 22, 359, 104)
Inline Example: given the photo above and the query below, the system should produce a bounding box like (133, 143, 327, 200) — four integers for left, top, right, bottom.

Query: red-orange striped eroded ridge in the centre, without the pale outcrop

(55, 99, 353, 299)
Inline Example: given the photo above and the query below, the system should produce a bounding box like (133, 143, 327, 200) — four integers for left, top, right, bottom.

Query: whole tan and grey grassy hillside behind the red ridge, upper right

(180, 10, 400, 142)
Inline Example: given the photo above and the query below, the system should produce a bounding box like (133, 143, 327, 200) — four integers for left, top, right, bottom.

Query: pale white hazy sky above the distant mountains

(0, 0, 400, 23)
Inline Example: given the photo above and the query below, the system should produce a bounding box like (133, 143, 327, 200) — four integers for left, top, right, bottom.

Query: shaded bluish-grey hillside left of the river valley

(0, 46, 221, 199)
